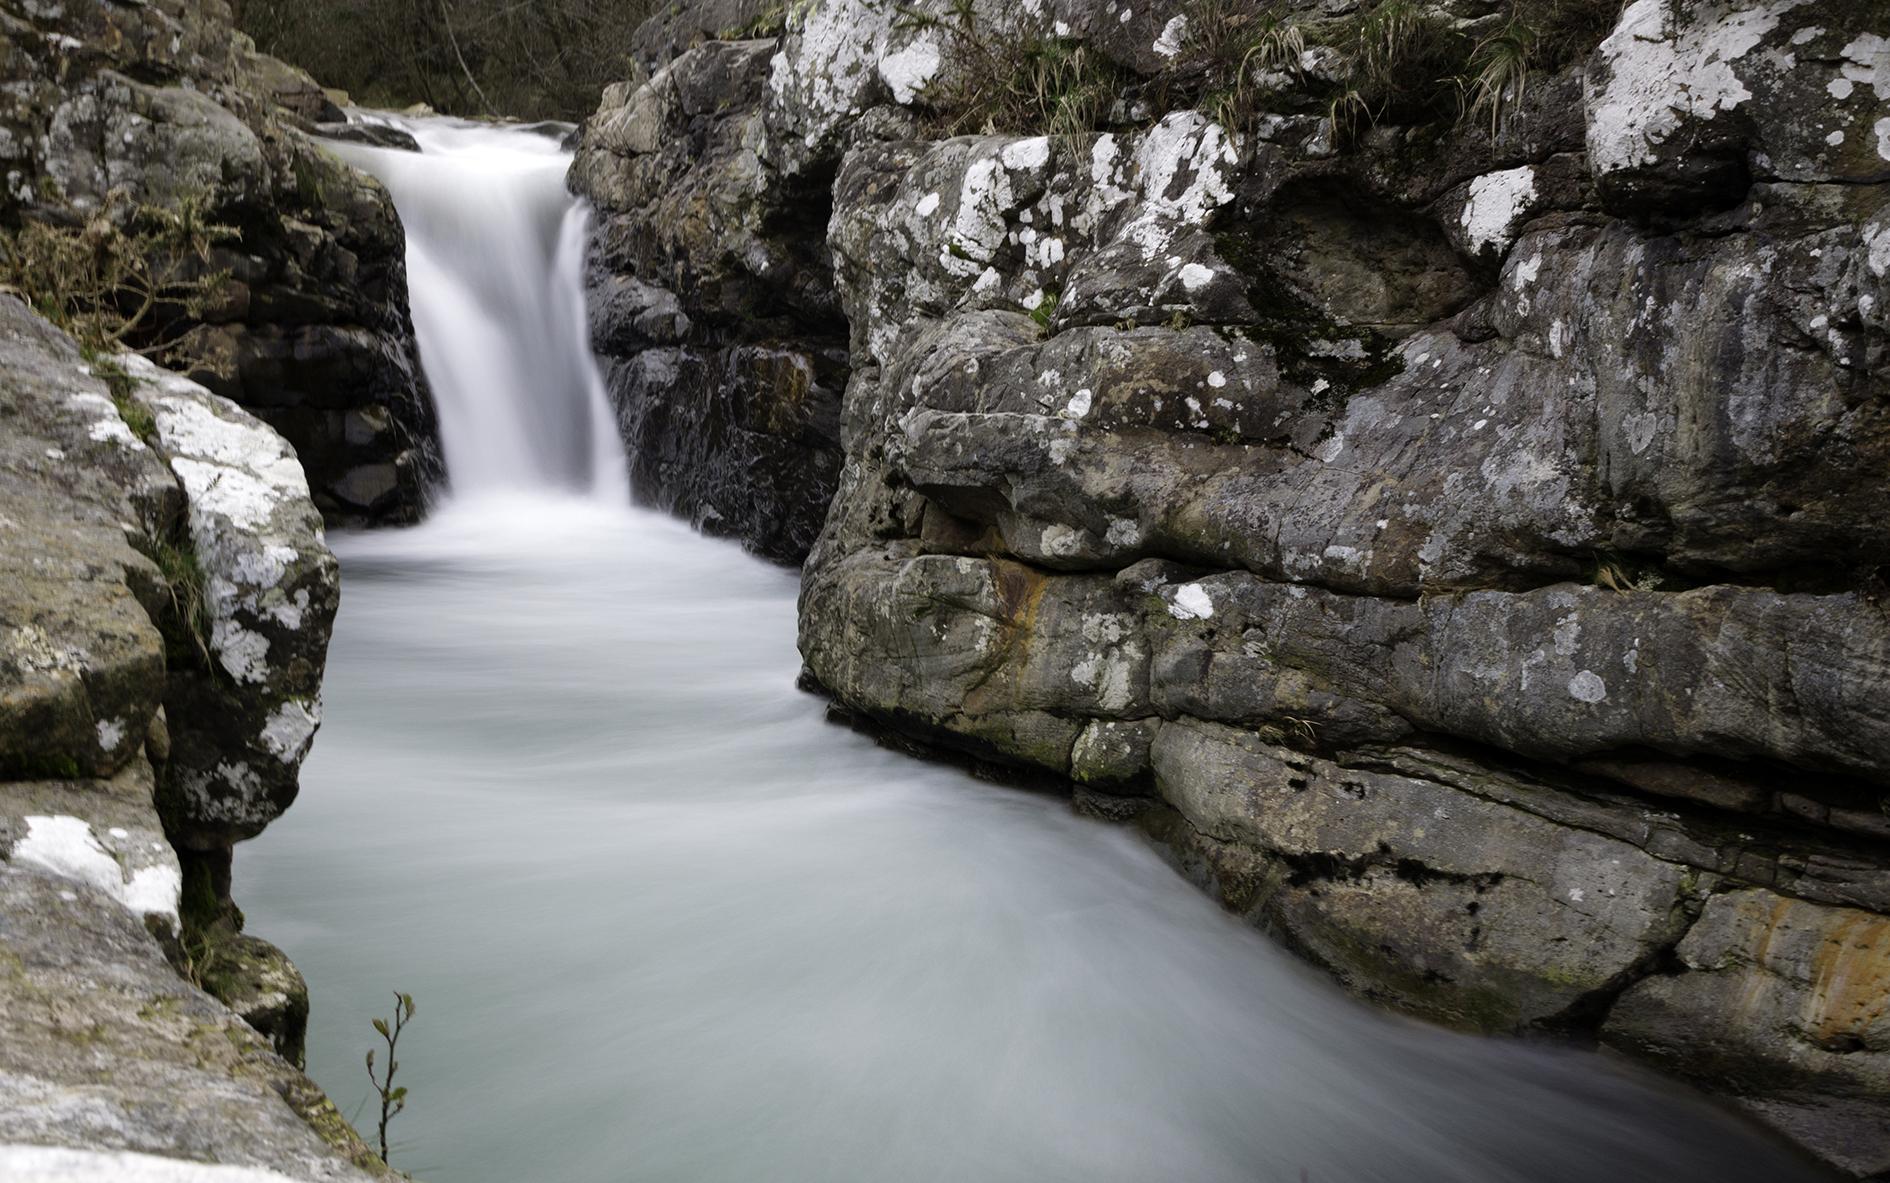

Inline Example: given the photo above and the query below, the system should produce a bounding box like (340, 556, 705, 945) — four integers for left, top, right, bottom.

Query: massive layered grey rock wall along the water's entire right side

(575, 0, 1890, 1175)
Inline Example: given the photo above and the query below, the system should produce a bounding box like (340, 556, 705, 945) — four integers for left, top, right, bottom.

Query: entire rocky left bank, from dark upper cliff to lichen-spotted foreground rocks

(0, 0, 438, 1181)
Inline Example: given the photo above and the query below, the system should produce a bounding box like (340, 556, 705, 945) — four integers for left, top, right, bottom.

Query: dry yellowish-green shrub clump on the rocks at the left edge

(0, 193, 238, 355)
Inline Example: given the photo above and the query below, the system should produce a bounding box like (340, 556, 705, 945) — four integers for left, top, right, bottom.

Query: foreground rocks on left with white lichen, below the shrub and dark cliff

(0, 297, 370, 1181)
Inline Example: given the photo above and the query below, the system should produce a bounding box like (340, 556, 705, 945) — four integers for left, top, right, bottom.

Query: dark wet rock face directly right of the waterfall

(571, 42, 847, 563)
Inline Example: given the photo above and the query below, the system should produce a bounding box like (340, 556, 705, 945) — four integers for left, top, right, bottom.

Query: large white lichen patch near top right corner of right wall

(1588, 0, 1809, 174)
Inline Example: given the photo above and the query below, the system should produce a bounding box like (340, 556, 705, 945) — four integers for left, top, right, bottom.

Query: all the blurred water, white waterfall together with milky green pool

(238, 121, 1844, 1183)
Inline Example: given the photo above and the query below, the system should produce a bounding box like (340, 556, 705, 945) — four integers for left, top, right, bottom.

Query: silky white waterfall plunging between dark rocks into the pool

(331, 113, 627, 501)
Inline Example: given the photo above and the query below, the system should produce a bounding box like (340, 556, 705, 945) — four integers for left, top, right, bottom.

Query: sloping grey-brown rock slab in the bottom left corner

(0, 864, 386, 1183)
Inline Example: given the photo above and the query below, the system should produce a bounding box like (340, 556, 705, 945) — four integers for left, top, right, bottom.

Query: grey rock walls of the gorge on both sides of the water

(0, 0, 1890, 1179)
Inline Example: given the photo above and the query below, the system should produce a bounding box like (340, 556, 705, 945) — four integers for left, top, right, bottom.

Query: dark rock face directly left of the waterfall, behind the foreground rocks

(0, 0, 438, 522)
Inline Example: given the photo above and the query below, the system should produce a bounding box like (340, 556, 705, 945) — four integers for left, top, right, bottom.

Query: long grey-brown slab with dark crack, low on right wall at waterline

(1153, 722, 1697, 1030)
